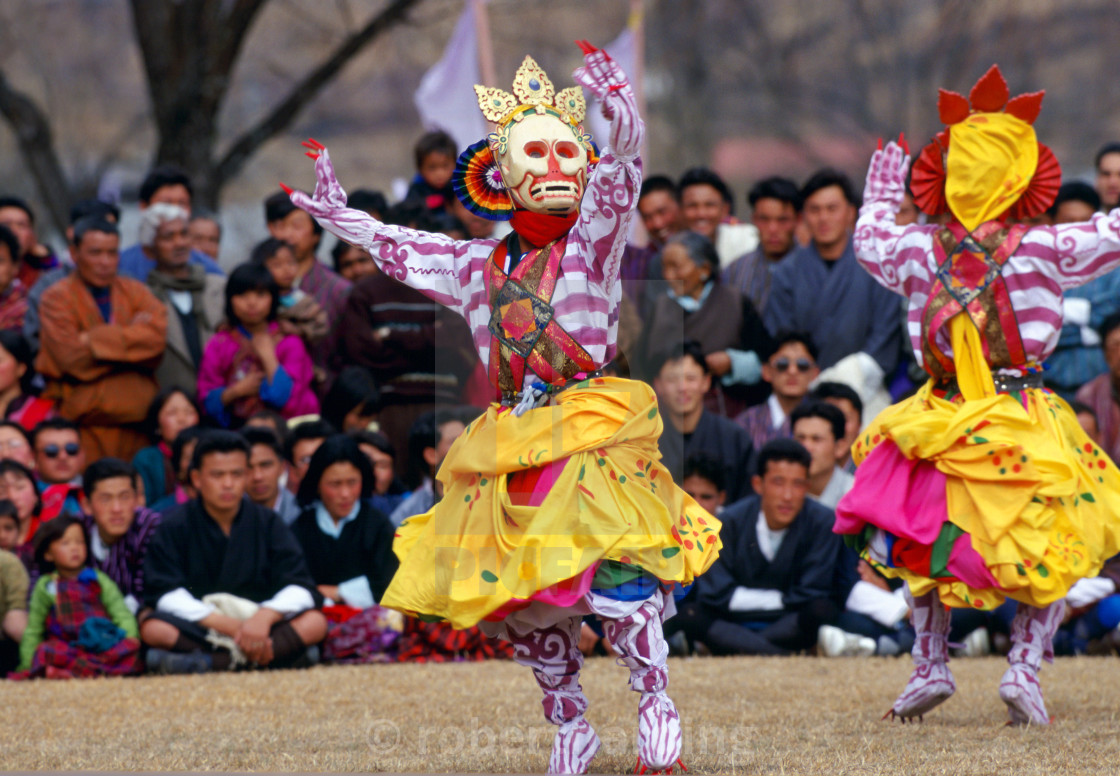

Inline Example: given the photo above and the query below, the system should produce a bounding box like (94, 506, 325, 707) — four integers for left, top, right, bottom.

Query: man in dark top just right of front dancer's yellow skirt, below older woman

(653, 340, 754, 502)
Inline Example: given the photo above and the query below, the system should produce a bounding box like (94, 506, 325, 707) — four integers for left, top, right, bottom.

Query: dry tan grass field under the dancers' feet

(0, 657, 1120, 776)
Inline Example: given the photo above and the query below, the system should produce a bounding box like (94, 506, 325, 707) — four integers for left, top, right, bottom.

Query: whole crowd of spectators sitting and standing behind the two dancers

(0, 132, 1120, 679)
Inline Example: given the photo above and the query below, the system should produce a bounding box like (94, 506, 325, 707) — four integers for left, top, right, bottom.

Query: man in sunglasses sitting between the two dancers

(735, 331, 821, 449)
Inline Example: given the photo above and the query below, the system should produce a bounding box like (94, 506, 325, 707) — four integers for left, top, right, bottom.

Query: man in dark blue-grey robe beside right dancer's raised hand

(764, 169, 902, 380)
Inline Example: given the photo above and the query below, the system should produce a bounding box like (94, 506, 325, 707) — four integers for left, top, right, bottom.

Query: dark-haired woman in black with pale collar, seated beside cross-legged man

(291, 434, 402, 663)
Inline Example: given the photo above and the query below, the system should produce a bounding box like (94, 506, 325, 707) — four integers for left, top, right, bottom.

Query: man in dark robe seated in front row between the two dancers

(692, 439, 840, 655)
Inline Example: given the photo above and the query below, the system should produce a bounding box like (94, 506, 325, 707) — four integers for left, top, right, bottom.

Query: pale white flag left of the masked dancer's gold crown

(412, 0, 489, 152)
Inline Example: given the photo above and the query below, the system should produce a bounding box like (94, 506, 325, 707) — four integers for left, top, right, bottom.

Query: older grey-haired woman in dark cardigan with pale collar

(631, 232, 772, 418)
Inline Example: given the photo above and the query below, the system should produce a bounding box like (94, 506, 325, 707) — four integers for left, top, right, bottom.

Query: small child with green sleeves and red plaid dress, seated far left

(17, 515, 140, 679)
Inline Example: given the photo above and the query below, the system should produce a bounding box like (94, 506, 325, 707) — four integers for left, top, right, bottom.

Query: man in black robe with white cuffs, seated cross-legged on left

(140, 431, 327, 673)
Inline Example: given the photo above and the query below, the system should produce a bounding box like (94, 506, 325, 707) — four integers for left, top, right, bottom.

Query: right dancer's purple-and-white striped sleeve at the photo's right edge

(1017, 208, 1120, 289)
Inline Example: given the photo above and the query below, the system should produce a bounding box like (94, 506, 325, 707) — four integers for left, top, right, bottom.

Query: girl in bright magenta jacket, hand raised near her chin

(198, 264, 319, 428)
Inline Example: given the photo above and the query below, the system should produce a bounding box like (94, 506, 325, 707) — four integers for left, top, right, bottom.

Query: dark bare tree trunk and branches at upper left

(0, 0, 421, 228)
